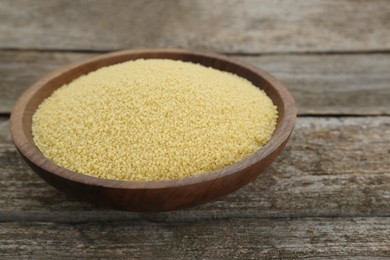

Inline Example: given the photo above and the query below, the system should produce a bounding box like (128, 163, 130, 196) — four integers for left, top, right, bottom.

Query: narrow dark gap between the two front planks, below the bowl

(0, 209, 390, 224)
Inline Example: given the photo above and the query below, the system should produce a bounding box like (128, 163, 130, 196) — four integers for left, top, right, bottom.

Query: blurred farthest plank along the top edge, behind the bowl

(0, 0, 390, 53)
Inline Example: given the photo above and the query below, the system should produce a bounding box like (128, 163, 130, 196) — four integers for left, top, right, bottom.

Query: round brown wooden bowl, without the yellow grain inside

(10, 49, 296, 211)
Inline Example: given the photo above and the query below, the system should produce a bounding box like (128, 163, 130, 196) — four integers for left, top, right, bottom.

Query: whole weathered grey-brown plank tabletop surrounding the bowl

(0, 0, 390, 259)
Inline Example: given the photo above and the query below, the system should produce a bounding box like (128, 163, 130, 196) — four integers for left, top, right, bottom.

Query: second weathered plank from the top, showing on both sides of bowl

(0, 51, 390, 115)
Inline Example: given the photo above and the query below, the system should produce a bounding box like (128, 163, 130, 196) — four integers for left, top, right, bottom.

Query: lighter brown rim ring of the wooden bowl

(10, 49, 297, 189)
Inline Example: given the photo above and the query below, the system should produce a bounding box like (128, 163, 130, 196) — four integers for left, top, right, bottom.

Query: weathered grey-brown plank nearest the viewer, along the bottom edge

(0, 218, 390, 259)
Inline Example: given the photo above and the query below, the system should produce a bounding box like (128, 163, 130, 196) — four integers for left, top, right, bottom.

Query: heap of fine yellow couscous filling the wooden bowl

(32, 59, 278, 181)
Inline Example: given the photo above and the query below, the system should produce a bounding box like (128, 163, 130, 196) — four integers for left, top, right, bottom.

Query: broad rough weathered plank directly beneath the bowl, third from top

(0, 117, 390, 223)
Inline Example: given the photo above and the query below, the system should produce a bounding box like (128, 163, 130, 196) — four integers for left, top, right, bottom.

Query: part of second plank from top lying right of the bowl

(247, 54, 390, 115)
